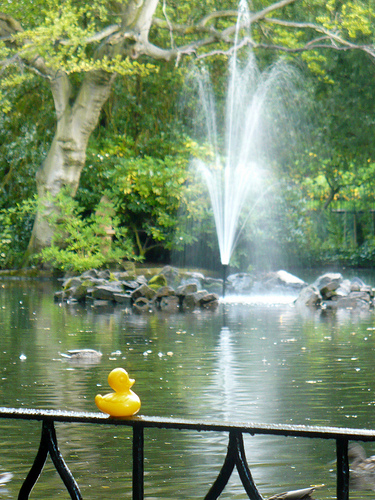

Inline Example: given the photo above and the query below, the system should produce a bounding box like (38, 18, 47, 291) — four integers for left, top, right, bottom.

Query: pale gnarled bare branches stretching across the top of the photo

(0, 0, 375, 79)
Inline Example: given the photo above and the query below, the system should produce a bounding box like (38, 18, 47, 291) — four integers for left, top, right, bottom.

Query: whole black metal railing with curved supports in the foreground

(0, 408, 375, 500)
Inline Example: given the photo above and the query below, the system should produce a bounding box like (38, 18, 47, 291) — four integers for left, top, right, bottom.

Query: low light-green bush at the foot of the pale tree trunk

(36, 193, 134, 272)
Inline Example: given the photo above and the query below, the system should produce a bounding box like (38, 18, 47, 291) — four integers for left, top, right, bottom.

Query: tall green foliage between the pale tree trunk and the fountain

(77, 65, 213, 259)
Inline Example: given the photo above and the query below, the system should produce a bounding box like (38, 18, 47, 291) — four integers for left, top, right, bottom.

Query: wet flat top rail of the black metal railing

(0, 407, 375, 441)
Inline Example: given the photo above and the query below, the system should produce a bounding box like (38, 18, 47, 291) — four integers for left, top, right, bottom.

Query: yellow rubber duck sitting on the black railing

(95, 368, 141, 417)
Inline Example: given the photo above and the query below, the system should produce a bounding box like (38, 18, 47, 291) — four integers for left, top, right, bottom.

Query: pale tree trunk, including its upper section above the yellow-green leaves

(24, 0, 159, 258)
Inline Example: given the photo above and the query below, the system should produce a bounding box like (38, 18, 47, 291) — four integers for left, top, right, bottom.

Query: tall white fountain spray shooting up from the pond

(196, 0, 302, 296)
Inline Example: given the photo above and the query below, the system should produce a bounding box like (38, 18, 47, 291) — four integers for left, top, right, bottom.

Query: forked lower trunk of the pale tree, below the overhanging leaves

(26, 71, 114, 260)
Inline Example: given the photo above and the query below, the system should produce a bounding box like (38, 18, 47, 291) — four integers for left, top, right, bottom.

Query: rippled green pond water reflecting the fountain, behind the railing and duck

(0, 280, 375, 500)
